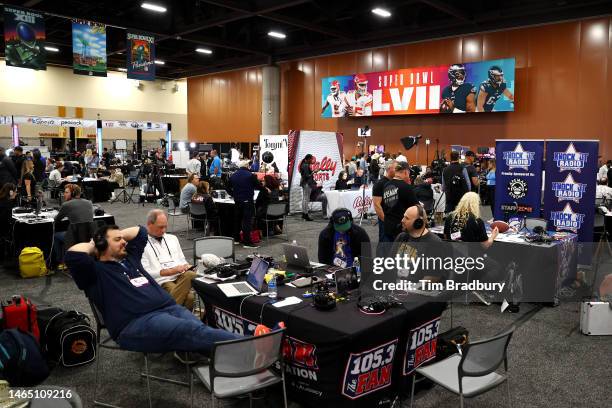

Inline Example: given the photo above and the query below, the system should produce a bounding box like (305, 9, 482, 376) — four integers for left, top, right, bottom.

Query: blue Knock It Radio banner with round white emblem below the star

(493, 139, 544, 221)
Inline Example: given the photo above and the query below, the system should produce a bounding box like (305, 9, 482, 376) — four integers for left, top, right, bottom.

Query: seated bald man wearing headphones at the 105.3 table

(391, 204, 447, 282)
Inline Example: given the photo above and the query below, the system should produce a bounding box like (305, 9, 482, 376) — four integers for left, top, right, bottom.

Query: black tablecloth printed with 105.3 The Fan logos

(193, 280, 446, 408)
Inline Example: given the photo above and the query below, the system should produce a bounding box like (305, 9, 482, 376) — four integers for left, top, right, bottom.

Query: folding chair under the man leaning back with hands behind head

(88, 299, 189, 408)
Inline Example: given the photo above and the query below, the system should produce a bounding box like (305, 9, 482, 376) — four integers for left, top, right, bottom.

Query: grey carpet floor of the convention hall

(0, 203, 612, 408)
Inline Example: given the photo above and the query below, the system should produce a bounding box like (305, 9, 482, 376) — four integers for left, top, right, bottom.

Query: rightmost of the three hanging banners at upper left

(127, 31, 155, 81)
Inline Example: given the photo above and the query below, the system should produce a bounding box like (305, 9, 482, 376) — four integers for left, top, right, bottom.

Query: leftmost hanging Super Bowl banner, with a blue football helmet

(4, 6, 47, 69)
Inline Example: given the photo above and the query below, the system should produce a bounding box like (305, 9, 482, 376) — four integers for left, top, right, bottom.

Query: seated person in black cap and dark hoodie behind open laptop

(319, 208, 371, 268)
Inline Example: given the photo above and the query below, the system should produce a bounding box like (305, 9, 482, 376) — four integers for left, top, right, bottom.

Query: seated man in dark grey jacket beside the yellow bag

(52, 184, 94, 265)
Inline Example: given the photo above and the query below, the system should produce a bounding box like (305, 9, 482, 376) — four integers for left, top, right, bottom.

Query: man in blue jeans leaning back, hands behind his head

(64, 225, 241, 354)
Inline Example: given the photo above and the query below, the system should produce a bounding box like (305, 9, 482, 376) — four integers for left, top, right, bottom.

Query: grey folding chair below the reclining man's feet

(190, 329, 287, 408)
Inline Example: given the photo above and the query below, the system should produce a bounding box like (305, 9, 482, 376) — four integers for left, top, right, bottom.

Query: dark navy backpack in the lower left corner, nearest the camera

(0, 329, 49, 387)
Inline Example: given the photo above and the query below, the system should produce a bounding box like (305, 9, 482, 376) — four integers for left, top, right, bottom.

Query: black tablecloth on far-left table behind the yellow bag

(13, 214, 115, 259)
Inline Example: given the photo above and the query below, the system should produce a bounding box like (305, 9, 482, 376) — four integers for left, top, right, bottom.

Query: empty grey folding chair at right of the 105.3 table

(410, 327, 514, 408)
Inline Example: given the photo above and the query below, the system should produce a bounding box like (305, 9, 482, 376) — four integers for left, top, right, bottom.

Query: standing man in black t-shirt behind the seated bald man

(383, 162, 418, 242)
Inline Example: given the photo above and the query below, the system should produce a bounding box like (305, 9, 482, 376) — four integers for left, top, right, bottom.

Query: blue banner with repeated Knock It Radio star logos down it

(544, 140, 599, 264)
